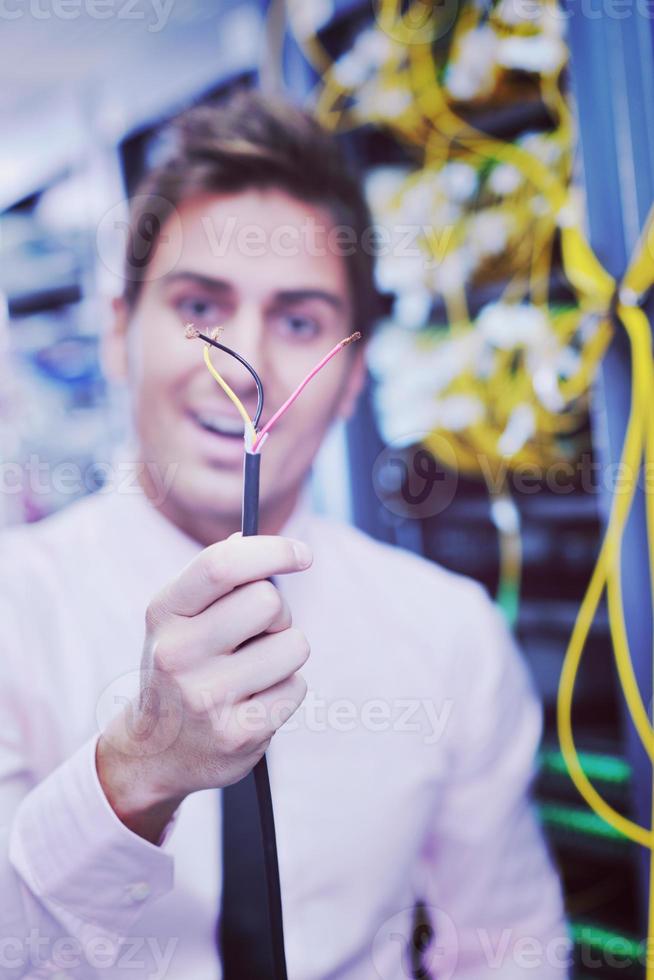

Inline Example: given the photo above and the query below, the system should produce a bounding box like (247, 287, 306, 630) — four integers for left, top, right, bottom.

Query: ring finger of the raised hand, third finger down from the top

(179, 629, 310, 706)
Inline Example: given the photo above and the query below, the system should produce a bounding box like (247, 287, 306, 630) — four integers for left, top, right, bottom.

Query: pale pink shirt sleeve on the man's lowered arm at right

(422, 588, 570, 980)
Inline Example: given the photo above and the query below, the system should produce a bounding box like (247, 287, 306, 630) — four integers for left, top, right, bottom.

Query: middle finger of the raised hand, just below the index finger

(153, 580, 292, 671)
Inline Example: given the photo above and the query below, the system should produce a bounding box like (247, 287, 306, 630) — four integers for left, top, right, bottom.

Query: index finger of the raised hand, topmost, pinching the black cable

(149, 535, 312, 621)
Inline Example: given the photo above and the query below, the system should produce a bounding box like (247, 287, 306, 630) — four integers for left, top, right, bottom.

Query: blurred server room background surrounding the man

(0, 0, 654, 980)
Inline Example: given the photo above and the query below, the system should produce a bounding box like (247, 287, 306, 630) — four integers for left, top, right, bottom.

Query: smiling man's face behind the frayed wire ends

(109, 189, 363, 521)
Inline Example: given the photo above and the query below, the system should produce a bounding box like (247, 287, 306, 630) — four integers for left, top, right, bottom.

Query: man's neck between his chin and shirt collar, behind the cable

(139, 467, 300, 548)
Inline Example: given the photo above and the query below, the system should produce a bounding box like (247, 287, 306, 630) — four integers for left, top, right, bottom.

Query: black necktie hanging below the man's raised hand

(218, 772, 275, 980)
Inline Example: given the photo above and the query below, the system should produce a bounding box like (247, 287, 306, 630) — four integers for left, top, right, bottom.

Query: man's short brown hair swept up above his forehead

(124, 90, 377, 332)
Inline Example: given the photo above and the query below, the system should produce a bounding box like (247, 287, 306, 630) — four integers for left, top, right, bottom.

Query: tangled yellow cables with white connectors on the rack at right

(287, 0, 654, 968)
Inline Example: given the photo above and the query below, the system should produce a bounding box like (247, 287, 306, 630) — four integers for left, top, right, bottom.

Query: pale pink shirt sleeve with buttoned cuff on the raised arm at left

(0, 560, 173, 980)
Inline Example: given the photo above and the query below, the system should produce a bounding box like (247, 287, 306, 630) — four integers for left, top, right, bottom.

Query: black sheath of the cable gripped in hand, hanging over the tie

(242, 450, 287, 980)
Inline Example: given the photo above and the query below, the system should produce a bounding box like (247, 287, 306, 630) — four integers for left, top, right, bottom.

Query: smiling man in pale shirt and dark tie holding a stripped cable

(0, 95, 567, 980)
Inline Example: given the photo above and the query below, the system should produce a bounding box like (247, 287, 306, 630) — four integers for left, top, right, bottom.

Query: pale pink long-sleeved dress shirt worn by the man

(0, 488, 567, 980)
